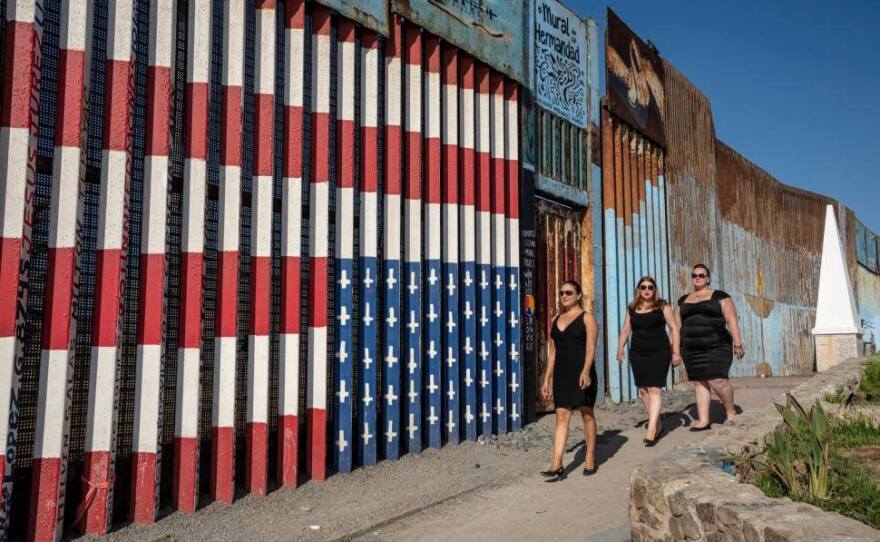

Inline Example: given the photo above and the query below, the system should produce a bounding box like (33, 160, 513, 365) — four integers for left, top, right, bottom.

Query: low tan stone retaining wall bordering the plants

(629, 358, 880, 542)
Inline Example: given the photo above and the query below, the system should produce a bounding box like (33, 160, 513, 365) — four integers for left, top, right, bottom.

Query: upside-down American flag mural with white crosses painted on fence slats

(0, 0, 524, 540)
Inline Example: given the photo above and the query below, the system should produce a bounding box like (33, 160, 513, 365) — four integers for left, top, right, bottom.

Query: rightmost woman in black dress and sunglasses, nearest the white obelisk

(675, 263, 746, 431)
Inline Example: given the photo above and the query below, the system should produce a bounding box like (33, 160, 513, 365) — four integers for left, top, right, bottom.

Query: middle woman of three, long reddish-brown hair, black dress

(617, 276, 681, 446)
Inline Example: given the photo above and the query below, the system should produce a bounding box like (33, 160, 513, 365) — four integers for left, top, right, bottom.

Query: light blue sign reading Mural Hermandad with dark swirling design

(533, 0, 589, 128)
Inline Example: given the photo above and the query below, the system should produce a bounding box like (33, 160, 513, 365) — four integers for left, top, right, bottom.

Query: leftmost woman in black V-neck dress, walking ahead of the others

(541, 280, 599, 482)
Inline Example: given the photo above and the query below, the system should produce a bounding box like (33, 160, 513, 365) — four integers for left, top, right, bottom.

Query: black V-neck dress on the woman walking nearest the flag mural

(550, 313, 598, 408)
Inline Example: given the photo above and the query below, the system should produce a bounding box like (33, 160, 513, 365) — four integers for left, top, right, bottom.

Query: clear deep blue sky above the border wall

(562, 0, 880, 233)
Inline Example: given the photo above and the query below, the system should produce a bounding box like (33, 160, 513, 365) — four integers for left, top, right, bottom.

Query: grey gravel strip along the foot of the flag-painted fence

(81, 387, 693, 542)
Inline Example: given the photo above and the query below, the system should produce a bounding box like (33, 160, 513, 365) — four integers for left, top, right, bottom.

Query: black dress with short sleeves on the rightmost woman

(678, 290, 733, 380)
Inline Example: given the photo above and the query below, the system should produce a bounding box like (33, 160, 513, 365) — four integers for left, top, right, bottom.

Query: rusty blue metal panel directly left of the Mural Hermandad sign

(391, 0, 530, 83)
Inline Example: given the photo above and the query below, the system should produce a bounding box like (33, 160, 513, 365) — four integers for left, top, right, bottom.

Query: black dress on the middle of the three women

(629, 308, 672, 388)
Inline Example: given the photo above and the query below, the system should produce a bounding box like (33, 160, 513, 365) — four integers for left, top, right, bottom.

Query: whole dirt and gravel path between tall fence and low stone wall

(94, 378, 803, 541)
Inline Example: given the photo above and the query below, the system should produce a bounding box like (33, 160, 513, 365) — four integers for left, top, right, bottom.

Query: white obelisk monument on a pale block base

(813, 205, 863, 372)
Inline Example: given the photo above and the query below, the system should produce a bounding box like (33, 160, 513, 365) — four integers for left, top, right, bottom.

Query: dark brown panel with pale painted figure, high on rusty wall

(605, 9, 666, 147)
